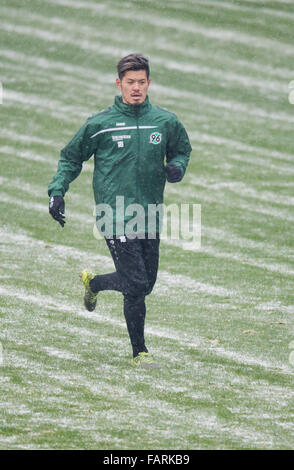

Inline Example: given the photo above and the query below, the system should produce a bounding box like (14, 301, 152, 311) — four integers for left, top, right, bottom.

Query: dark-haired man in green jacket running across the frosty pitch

(48, 54, 192, 368)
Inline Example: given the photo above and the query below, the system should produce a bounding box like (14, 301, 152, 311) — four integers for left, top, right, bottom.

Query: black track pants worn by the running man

(90, 237, 159, 357)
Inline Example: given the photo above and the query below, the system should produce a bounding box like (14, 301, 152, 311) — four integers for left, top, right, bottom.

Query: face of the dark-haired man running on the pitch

(116, 70, 150, 106)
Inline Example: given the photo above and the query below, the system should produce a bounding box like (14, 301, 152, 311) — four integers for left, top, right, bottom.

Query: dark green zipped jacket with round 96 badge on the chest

(48, 96, 192, 234)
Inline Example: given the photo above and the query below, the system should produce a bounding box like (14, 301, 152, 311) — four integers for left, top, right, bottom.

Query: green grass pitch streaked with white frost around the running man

(0, 0, 294, 449)
